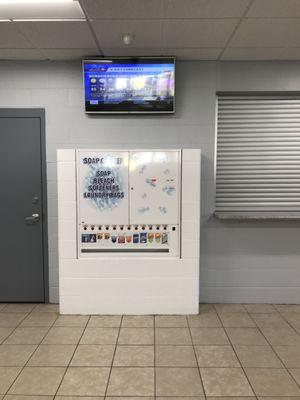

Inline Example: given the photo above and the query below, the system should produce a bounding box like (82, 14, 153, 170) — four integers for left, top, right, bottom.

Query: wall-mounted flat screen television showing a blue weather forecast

(83, 57, 175, 113)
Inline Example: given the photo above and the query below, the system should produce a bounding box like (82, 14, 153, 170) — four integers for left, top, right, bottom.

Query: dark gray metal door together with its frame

(0, 109, 47, 302)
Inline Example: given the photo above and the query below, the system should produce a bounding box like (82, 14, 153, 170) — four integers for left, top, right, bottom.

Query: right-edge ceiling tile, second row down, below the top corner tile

(229, 19, 300, 47)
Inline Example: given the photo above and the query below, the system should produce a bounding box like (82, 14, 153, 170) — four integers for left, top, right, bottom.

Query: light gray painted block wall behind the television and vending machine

(0, 61, 300, 303)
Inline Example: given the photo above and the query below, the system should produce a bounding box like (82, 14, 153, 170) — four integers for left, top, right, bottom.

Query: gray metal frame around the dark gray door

(0, 108, 49, 303)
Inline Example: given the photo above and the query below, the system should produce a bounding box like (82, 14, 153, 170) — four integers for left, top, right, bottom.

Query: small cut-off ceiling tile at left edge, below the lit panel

(0, 22, 33, 49)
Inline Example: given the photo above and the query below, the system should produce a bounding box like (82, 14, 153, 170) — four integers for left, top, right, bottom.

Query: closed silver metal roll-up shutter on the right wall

(216, 94, 300, 218)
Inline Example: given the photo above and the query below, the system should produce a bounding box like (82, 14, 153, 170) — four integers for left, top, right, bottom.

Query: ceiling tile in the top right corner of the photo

(247, 0, 300, 18)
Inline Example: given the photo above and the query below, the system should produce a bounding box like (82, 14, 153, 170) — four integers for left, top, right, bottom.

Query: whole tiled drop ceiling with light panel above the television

(0, 0, 300, 60)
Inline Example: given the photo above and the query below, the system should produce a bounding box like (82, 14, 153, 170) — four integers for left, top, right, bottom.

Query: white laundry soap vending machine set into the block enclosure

(76, 150, 181, 257)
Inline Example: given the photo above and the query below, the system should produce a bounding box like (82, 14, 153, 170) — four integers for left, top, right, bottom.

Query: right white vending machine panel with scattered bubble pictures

(129, 150, 180, 225)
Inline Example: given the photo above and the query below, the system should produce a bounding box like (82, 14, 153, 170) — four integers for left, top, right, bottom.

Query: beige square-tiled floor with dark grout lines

(0, 304, 300, 400)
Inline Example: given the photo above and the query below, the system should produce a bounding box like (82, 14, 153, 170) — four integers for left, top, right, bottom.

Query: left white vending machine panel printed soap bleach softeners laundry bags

(77, 150, 129, 226)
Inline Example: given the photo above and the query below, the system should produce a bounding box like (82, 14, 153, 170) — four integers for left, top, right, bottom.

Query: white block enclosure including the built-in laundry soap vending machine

(58, 149, 200, 314)
